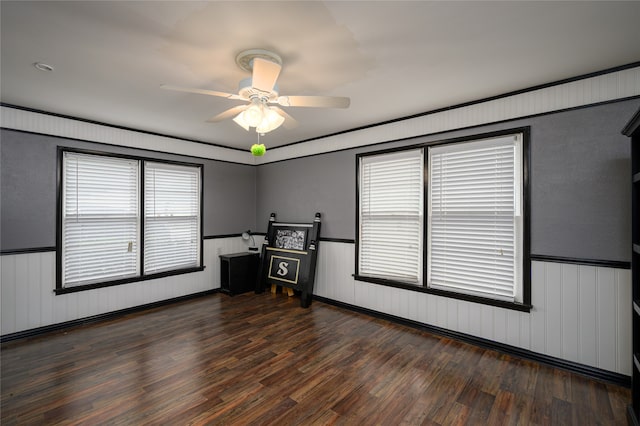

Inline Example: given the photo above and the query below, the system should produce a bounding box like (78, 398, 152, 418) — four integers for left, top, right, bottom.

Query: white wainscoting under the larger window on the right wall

(314, 241, 631, 375)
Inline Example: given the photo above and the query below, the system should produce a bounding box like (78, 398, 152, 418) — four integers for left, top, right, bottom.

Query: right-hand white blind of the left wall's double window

(144, 162, 200, 274)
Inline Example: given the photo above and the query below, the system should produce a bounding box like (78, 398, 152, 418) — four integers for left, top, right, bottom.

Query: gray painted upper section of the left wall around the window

(0, 129, 256, 251)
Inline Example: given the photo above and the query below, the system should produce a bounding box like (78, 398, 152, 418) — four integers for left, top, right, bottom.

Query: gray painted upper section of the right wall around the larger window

(256, 99, 640, 261)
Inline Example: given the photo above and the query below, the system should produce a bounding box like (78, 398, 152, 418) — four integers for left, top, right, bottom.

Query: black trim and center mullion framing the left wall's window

(54, 145, 205, 295)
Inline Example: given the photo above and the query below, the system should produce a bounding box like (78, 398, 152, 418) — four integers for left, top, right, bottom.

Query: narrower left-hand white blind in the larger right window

(358, 149, 424, 285)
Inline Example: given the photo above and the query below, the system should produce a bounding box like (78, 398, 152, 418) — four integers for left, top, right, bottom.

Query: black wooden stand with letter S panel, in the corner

(256, 213, 320, 308)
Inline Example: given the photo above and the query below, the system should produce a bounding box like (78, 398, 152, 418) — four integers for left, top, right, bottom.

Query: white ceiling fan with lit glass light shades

(160, 49, 350, 134)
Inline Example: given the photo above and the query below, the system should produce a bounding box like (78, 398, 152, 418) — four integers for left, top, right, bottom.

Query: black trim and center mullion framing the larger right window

(353, 126, 533, 312)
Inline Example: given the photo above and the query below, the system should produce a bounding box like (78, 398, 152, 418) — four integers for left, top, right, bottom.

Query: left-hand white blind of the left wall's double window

(61, 152, 139, 287)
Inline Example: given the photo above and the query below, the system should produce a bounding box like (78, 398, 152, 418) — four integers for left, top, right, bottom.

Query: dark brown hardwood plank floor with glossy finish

(1, 292, 630, 425)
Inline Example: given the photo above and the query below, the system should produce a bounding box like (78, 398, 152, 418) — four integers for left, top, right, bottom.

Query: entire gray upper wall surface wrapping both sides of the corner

(0, 99, 640, 261)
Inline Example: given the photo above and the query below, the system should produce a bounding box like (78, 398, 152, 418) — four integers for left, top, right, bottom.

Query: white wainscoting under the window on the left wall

(0, 237, 247, 335)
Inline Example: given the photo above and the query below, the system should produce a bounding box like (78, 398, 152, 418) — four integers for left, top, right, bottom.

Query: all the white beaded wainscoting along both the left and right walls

(0, 237, 631, 375)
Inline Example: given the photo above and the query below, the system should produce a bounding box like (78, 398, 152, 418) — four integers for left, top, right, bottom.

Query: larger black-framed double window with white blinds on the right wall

(355, 128, 531, 311)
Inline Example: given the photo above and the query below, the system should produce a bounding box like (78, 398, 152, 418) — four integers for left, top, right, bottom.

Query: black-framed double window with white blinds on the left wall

(56, 149, 202, 293)
